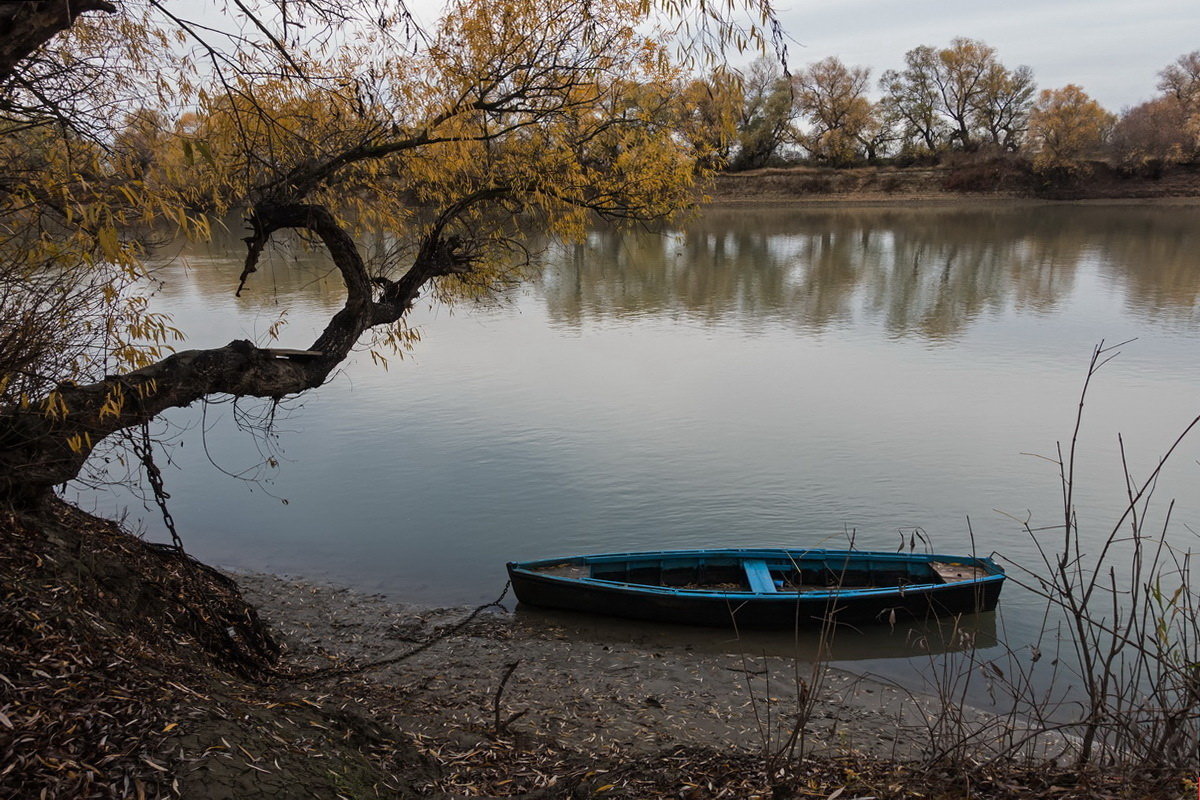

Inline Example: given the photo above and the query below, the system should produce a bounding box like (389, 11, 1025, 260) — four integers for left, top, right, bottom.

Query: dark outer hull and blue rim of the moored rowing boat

(508, 551, 1004, 630)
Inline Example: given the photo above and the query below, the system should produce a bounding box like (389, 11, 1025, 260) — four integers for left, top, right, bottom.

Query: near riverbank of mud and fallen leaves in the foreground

(0, 503, 1194, 800)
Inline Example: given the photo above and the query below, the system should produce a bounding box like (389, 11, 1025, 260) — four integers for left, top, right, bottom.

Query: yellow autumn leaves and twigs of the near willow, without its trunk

(0, 0, 770, 419)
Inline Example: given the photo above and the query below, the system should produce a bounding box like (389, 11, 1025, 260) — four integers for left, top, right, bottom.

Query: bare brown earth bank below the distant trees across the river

(707, 158, 1200, 205)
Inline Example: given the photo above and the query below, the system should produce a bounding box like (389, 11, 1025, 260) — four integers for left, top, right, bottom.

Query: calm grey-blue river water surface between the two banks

(77, 206, 1200, 681)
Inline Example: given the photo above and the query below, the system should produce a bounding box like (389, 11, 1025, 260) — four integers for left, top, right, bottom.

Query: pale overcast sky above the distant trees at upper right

(778, 0, 1200, 112)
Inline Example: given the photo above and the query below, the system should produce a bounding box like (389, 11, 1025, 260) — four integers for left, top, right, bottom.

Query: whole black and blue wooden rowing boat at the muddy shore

(508, 548, 1004, 628)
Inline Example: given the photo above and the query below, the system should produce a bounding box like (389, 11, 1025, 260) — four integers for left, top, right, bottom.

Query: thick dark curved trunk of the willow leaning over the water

(0, 204, 472, 506)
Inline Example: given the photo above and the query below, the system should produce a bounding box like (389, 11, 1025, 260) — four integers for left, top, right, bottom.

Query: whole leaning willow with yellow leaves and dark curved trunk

(0, 0, 773, 506)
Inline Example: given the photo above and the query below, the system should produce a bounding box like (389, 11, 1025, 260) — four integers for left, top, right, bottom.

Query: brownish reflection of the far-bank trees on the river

(540, 205, 1200, 342)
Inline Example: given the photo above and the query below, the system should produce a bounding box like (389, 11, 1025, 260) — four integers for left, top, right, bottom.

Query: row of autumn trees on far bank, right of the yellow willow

(688, 37, 1200, 173)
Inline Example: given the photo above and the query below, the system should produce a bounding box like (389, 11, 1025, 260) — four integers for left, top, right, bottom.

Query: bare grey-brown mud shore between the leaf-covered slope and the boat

(234, 575, 1032, 759)
